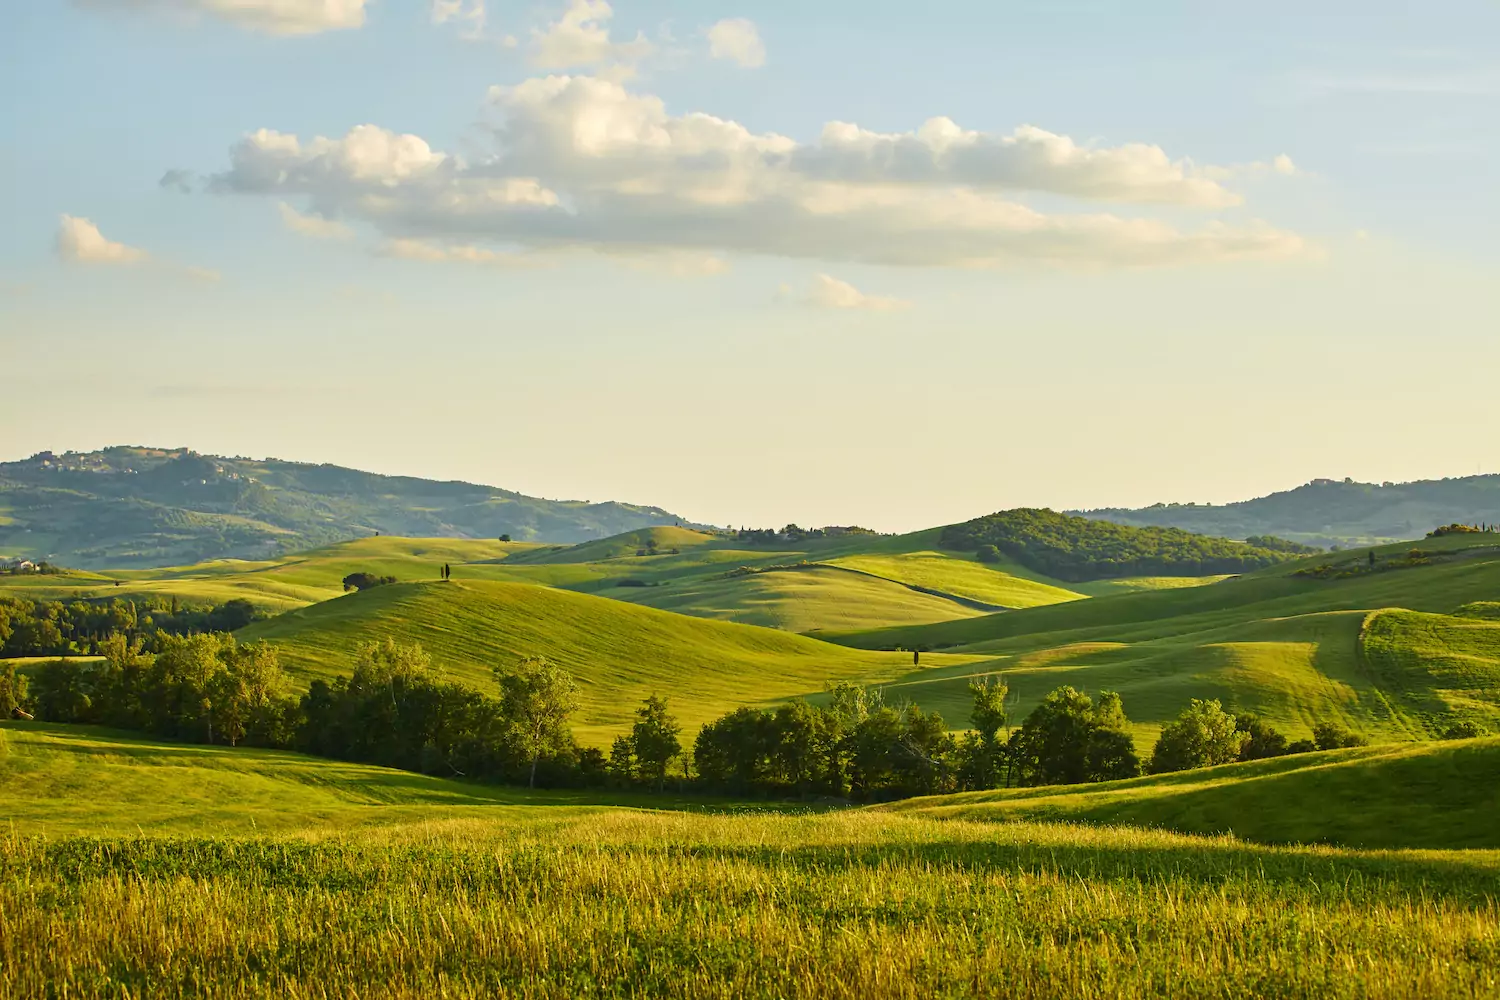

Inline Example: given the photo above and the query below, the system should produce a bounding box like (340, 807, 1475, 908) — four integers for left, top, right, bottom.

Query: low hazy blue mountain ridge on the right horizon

(1070, 475, 1500, 547)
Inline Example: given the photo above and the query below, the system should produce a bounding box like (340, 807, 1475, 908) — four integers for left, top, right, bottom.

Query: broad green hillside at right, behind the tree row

(824, 537, 1500, 750)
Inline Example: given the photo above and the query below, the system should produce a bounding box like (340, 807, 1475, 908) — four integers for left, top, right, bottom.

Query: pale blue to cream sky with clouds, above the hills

(0, 0, 1500, 531)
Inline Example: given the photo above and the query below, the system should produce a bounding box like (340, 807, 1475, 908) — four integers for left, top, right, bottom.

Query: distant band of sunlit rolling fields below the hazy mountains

(0, 526, 1242, 633)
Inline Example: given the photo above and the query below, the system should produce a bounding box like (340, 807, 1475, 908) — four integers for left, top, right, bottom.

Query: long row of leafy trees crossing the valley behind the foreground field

(0, 633, 1481, 802)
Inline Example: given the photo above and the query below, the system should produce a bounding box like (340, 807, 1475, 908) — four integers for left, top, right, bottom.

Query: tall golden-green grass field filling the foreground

(0, 724, 1500, 999)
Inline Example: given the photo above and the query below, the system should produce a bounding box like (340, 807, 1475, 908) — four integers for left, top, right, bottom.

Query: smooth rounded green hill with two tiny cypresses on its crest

(237, 580, 930, 742)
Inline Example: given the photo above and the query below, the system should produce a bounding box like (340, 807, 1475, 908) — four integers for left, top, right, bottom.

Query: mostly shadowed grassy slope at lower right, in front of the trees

(876, 738, 1500, 850)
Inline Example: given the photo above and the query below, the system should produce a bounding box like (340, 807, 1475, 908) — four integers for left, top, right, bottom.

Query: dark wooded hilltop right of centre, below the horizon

(941, 508, 1295, 582)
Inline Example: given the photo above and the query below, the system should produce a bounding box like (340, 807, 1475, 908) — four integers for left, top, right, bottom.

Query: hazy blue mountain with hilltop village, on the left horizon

(0, 447, 702, 568)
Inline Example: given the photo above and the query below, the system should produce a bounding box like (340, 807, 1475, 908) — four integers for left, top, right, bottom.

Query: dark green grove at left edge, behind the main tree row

(0, 597, 257, 657)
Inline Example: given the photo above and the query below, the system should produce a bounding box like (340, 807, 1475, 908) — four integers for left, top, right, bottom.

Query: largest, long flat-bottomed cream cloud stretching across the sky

(209, 75, 1307, 267)
